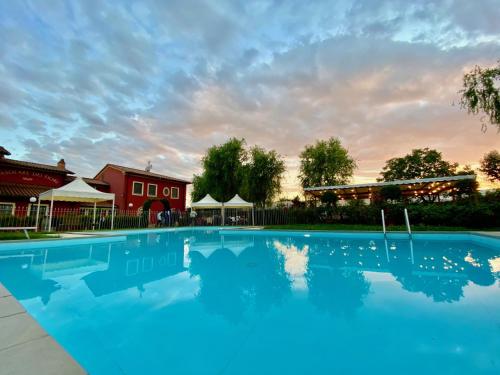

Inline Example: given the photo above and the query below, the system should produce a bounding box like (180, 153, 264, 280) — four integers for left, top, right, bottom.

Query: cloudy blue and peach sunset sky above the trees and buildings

(0, 0, 500, 200)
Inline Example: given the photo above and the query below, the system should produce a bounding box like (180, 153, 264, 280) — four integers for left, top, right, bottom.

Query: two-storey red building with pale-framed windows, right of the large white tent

(95, 164, 191, 211)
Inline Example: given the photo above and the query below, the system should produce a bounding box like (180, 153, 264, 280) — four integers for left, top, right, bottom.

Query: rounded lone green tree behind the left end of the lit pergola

(299, 137, 356, 188)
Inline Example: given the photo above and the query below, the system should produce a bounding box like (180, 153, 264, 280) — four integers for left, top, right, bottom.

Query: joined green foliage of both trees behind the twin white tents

(191, 138, 285, 205)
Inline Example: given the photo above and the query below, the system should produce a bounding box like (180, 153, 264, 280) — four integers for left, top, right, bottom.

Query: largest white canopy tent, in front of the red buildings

(36, 177, 115, 232)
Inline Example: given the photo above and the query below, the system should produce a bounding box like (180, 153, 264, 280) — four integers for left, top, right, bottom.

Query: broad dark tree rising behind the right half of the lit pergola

(378, 148, 458, 181)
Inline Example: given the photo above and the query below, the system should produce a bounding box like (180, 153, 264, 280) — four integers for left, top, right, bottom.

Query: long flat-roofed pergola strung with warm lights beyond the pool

(304, 175, 476, 200)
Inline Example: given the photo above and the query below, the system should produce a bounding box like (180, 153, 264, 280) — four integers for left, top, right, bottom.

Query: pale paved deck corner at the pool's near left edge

(0, 283, 87, 375)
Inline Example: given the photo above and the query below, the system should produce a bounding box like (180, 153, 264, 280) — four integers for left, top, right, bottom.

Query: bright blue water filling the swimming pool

(0, 230, 500, 375)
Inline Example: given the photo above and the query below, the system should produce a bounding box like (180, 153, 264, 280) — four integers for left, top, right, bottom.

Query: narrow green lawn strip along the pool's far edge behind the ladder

(264, 224, 500, 232)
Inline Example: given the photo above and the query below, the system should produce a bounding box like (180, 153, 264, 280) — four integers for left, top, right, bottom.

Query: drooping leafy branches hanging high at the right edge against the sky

(460, 61, 500, 131)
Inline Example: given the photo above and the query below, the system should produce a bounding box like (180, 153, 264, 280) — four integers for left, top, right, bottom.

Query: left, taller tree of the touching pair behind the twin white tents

(191, 138, 247, 201)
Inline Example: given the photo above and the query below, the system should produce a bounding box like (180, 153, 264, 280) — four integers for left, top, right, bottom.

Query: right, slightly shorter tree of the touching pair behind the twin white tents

(242, 146, 285, 206)
